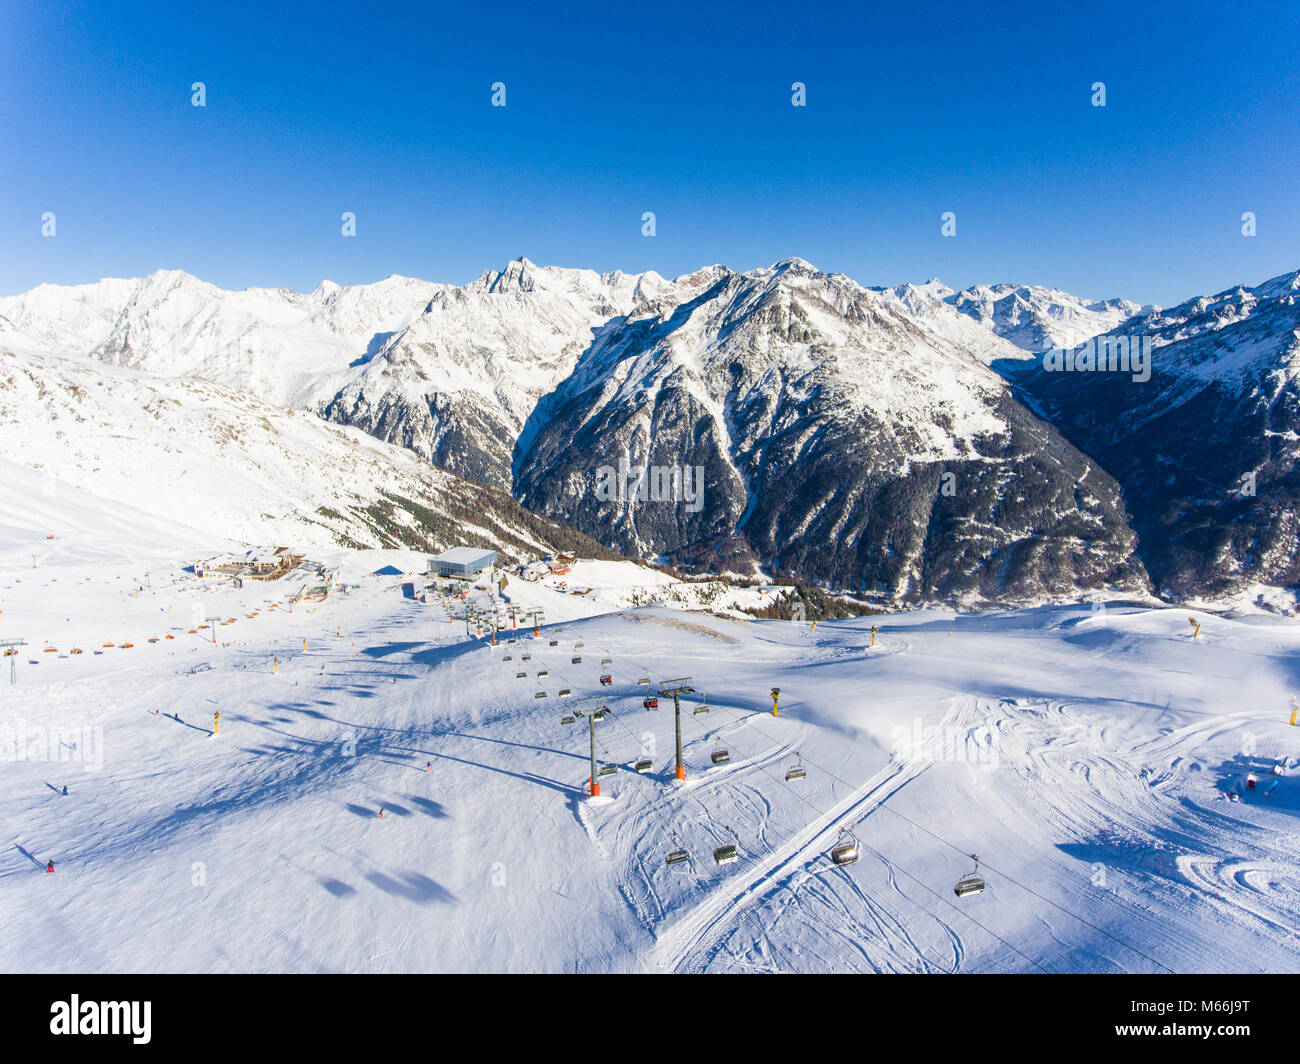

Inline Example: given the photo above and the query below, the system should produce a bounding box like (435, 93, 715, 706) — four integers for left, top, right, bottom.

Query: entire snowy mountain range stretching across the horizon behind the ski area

(0, 259, 1300, 605)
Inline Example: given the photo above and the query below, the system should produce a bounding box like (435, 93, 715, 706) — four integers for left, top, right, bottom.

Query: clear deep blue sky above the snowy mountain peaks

(0, 0, 1300, 304)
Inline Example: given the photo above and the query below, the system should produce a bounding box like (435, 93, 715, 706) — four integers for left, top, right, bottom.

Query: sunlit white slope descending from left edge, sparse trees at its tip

(0, 348, 618, 559)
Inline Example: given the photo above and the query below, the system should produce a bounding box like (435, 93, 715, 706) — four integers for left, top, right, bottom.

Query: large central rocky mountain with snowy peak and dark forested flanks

(516, 260, 1143, 601)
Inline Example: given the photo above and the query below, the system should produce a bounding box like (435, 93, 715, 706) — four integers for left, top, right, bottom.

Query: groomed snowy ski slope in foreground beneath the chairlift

(0, 481, 1300, 972)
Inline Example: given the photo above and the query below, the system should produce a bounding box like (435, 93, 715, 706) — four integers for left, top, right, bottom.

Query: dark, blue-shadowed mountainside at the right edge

(1008, 272, 1300, 596)
